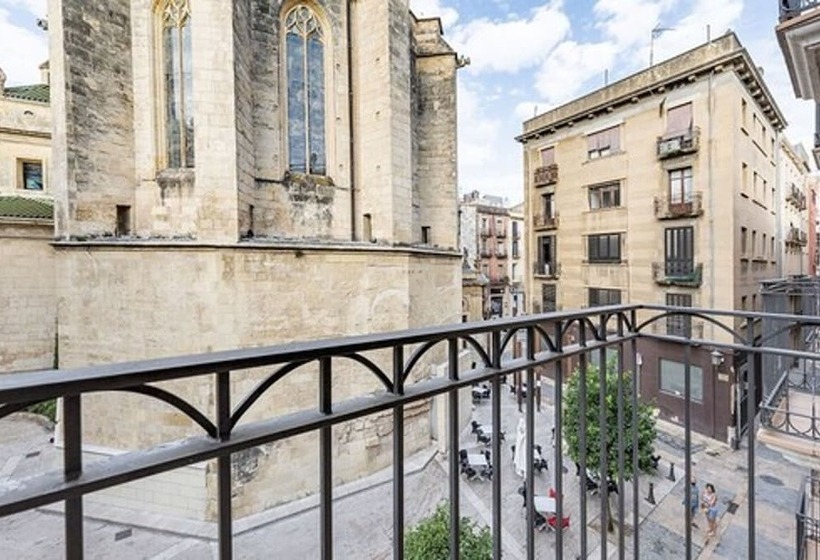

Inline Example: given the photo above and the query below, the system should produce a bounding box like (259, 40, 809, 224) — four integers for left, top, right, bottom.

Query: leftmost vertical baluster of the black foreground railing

(63, 395, 83, 560)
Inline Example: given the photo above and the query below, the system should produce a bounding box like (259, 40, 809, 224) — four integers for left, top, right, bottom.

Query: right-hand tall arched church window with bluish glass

(285, 6, 327, 175)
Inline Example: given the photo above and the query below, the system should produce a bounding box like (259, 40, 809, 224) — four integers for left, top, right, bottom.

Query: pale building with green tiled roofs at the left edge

(0, 63, 57, 373)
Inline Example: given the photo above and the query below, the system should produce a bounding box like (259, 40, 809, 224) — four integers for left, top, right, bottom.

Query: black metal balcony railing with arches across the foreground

(0, 305, 820, 560)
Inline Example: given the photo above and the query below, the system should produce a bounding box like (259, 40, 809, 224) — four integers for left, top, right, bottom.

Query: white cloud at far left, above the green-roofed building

(0, 6, 48, 85)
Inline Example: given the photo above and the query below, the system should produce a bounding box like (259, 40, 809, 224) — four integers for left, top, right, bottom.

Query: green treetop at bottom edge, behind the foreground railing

(404, 502, 493, 560)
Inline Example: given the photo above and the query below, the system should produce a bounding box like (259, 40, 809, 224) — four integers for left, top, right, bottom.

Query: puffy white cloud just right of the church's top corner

(450, 2, 570, 74)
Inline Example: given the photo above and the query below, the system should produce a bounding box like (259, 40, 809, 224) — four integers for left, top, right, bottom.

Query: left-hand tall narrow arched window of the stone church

(157, 0, 194, 168)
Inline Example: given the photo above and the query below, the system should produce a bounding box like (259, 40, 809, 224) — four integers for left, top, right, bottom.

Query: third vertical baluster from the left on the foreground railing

(319, 357, 333, 560)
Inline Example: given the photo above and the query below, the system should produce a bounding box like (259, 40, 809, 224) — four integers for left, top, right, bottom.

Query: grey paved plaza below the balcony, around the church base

(0, 378, 808, 560)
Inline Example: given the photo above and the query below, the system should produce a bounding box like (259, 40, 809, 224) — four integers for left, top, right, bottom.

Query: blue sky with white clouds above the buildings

(0, 0, 814, 203)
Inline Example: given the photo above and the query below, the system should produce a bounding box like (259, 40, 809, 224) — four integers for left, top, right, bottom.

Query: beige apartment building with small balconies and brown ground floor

(518, 33, 805, 440)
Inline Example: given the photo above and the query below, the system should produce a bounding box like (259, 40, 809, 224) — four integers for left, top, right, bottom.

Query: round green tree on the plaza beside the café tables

(562, 360, 657, 532)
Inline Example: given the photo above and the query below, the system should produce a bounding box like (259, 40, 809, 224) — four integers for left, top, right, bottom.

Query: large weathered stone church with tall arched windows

(49, 0, 462, 520)
